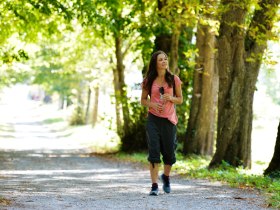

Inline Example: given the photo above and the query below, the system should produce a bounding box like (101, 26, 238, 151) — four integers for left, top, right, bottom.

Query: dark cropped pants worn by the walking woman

(146, 113, 177, 165)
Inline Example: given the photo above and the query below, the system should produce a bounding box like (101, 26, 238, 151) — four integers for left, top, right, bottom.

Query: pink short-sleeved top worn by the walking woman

(149, 75, 182, 125)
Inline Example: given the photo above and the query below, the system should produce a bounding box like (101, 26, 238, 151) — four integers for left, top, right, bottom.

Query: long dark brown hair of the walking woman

(143, 50, 173, 95)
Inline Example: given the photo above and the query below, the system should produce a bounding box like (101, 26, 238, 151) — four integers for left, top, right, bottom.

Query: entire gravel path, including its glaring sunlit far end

(0, 88, 272, 210)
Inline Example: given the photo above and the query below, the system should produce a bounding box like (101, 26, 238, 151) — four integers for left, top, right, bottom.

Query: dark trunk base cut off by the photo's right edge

(264, 122, 280, 177)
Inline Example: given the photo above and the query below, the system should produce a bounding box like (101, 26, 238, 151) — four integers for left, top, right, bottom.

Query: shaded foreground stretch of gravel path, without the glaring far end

(0, 151, 270, 210)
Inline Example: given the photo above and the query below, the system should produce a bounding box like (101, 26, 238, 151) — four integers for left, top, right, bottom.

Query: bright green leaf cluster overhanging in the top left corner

(0, 0, 72, 44)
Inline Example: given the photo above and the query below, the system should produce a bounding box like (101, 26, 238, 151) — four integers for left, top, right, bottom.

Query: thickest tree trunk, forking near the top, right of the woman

(209, 0, 279, 168)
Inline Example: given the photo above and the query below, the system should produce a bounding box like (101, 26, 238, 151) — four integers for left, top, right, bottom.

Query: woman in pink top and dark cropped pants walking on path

(141, 51, 183, 195)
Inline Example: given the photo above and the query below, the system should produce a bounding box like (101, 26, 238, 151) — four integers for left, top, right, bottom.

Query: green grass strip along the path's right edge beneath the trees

(115, 153, 280, 209)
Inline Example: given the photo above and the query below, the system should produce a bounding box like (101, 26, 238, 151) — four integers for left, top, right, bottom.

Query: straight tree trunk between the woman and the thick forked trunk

(183, 20, 218, 155)
